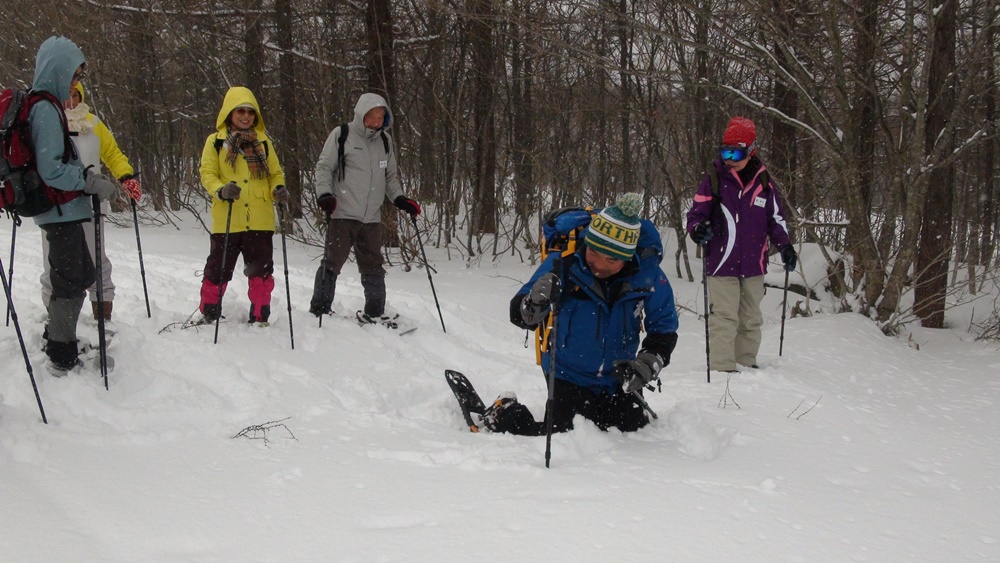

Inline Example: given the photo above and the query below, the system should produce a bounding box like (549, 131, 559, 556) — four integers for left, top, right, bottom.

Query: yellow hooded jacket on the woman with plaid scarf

(200, 86, 285, 233)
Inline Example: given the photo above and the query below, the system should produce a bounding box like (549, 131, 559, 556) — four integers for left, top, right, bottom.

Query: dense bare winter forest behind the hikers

(0, 0, 1000, 332)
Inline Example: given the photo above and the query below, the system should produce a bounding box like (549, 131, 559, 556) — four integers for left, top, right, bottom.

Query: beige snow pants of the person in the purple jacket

(708, 276, 764, 371)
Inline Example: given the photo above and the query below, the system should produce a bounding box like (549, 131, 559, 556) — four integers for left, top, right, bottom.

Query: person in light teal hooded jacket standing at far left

(28, 37, 117, 376)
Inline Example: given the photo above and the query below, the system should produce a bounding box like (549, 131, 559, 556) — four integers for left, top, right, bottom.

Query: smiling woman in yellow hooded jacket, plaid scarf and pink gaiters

(199, 86, 288, 326)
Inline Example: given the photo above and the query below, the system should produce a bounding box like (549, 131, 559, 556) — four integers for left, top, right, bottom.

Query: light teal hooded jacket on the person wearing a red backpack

(28, 37, 93, 225)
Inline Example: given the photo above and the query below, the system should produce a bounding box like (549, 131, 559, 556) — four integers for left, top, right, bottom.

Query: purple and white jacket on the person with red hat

(687, 160, 791, 278)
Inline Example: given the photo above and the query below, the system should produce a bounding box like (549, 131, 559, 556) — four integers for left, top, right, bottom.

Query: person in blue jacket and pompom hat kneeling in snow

(492, 193, 678, 436)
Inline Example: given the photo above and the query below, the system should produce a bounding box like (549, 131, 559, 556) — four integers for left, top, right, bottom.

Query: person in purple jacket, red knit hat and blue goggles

(687, 117, 798, 372)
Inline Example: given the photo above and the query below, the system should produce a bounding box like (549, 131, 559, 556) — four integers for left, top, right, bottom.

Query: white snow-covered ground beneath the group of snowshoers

(0, 214, 1000, 563)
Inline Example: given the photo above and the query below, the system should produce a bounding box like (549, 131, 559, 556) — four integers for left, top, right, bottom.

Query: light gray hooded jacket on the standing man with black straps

(316, 93, 403, 223)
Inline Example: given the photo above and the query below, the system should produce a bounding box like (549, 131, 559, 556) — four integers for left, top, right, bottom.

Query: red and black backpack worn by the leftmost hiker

(0, 88, 81, 217)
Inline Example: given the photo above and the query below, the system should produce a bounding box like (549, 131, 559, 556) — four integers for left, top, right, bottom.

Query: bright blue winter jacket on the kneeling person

(514, 229, 678, 394)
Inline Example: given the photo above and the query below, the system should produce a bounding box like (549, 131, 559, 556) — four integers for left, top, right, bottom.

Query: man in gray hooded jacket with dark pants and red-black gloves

(309, 93, 420, 323)
